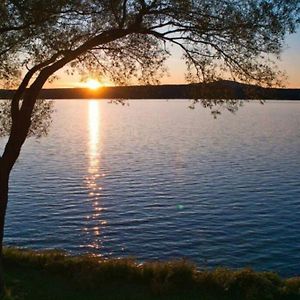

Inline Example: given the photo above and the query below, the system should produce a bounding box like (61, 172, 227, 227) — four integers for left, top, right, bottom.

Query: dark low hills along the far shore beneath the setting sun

(0, 80, 300, 100)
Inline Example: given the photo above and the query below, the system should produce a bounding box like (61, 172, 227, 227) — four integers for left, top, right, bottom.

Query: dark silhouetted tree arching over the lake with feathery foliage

(0, 0, 299, 290)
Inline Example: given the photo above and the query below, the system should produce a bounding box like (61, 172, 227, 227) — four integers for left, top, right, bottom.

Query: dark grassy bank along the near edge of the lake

(4, 249, 300, 300)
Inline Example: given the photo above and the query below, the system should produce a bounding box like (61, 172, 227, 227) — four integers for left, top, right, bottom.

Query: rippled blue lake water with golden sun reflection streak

(0, 100, 300, 276)
